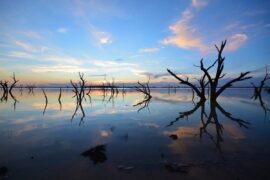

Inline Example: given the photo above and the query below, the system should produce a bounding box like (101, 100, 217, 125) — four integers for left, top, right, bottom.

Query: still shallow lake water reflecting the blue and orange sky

(0, 89, 270, 180)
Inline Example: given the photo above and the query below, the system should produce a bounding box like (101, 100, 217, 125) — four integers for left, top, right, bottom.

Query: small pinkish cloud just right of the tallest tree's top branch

(226, 34, 248, 51)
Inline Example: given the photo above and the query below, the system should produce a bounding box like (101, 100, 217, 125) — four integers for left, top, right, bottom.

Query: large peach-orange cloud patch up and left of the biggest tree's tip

(163, 9, 208, 52)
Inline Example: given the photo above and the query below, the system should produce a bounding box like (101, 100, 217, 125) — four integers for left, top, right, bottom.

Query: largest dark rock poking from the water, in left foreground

(81, 145, 107, 164)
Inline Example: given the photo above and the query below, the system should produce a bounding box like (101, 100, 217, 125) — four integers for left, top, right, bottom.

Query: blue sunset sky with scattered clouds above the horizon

(0, 0, 270, 84)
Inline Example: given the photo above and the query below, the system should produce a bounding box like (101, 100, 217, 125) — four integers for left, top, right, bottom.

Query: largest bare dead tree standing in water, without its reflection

(167, 40, 251, 100)
